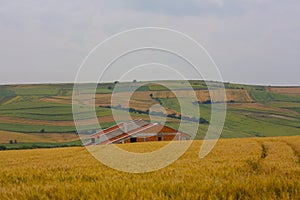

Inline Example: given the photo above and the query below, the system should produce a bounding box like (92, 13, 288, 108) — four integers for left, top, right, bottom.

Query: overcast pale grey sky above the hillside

(0, 0, 300, 85)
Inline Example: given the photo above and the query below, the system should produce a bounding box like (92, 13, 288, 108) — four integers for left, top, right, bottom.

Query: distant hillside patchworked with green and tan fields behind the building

(0, 80, 300, 148)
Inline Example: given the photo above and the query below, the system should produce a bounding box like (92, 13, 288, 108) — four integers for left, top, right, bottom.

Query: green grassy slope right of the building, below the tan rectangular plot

(162, 98, 300, 139)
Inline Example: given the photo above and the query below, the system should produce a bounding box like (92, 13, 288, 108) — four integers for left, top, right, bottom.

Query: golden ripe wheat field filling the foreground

(0, 136, 300, 199)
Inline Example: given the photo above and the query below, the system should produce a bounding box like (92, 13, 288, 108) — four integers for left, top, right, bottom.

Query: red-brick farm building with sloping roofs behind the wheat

(89, 119, 191, 145)
